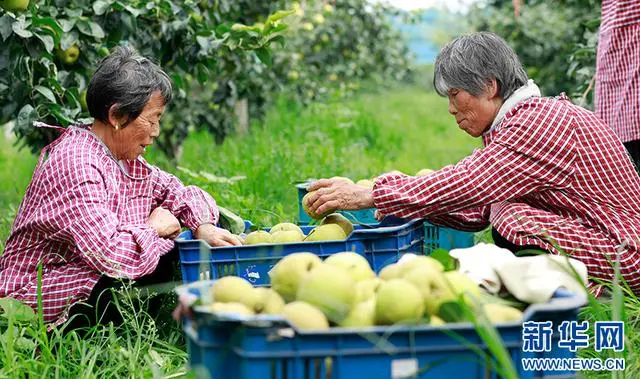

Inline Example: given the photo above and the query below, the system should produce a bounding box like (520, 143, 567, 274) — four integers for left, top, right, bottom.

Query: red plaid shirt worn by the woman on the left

(0, 127, 218, 326)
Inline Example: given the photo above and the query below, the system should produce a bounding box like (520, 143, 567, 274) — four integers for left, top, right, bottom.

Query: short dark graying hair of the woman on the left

(87, 46, 173, 126)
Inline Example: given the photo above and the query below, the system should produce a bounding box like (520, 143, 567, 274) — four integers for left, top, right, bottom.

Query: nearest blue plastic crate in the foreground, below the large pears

(178, 282, 585, 379)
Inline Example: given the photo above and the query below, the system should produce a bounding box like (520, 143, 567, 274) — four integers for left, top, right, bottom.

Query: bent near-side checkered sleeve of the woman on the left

(53, 166, 174, 279)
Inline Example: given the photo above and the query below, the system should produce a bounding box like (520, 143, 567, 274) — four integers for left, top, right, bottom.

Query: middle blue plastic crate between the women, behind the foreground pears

(176, 217, 424, 286)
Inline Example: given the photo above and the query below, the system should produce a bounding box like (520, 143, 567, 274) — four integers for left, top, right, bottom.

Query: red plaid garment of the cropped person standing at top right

(595, 0, 640, 142)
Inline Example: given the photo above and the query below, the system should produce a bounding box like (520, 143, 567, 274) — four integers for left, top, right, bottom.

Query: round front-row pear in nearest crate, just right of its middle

(376, 279, 424, 325)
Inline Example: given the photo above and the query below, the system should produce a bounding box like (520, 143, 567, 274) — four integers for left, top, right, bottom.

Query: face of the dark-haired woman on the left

(113, 92, 165, 160)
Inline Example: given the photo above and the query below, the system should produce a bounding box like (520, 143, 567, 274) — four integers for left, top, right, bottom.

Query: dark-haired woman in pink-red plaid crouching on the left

(0, 48, 241, 327)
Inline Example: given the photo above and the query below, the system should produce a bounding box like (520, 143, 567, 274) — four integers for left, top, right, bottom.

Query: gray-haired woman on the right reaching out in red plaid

(307, 32, 640, 293)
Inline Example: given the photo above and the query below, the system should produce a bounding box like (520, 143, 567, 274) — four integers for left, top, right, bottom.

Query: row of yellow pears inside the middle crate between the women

(244, 213, 353, 245)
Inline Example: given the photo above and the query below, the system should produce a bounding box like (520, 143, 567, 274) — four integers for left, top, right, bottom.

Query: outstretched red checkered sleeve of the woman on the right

(373, 106, 576, 218)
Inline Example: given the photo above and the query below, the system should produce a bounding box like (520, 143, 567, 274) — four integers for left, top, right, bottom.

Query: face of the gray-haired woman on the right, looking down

(448, 88, 502, 137)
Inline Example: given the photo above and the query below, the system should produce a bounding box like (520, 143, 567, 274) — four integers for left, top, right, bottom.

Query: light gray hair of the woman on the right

(433, 32, 529, 99)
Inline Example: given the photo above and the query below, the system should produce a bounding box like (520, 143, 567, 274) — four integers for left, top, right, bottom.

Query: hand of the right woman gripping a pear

(307, 179, 374, 218)
